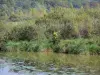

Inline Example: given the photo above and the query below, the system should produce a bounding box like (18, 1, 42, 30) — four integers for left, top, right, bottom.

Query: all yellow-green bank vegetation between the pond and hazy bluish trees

(0, 0, 100, 55)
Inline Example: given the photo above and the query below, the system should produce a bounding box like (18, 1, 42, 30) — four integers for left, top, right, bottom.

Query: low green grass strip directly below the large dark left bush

(6, 41, 40, 52)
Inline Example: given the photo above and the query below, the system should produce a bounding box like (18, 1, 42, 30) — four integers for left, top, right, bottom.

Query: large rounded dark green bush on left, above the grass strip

(8, 26, 37, 41)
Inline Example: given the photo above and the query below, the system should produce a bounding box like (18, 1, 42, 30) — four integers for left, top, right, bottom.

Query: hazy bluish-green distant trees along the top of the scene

(0, 0, 100, 21)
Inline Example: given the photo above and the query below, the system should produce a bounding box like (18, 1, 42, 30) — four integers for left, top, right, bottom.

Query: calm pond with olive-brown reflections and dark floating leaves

(0, 52, 100, 75)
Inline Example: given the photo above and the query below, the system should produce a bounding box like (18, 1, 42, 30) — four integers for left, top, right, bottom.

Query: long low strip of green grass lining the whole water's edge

(1, 39, 100, 55)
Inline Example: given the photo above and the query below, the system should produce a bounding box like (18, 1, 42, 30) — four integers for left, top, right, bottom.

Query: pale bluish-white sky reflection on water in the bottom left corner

(0, 59, 51, 75)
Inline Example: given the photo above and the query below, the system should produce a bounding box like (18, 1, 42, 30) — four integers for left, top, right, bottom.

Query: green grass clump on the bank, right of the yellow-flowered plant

(60, 39, 100, 55)
